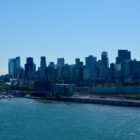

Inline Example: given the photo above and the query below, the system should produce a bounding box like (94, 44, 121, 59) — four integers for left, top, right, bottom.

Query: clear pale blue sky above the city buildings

(0, 0, 140, 74)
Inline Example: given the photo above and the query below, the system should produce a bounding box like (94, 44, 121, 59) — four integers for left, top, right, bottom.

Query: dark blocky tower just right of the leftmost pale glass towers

(25, 57, 36, 80)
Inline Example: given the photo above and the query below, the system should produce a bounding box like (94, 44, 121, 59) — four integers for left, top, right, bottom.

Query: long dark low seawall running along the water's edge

(26, 97, 140, 107)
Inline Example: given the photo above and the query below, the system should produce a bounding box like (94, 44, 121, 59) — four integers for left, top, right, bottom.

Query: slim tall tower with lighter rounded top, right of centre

(101, 52, 109, 68)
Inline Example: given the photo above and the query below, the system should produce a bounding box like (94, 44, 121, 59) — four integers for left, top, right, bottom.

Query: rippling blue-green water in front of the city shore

(0, 98, 140, 140)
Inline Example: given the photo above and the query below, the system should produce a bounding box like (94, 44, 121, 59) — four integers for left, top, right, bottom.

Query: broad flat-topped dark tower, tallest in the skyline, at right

(116, 50, 131, 64)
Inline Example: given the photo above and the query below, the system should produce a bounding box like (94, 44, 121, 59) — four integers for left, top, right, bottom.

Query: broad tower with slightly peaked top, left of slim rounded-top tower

(85, 55, 97, 78)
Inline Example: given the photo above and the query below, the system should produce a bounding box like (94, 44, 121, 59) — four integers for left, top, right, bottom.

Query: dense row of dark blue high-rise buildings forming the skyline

(7, 50, 140, 86)
